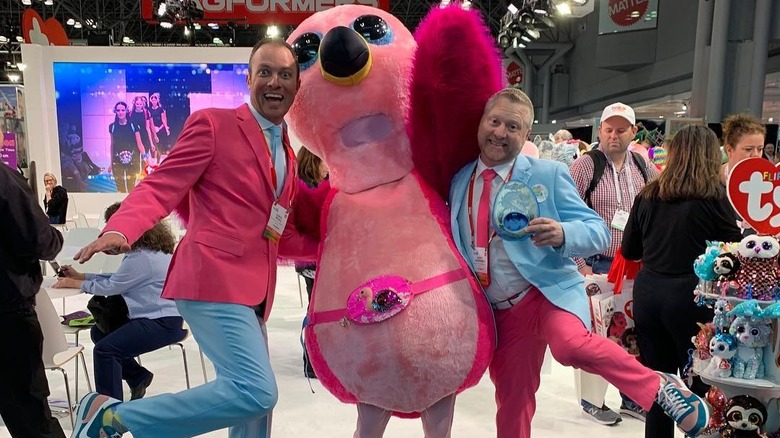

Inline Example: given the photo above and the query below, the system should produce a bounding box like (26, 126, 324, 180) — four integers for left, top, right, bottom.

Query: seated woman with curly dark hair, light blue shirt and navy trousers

(54, 202, 187, 400)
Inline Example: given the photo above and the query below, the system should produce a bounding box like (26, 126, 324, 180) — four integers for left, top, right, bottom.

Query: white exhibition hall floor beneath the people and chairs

(0, 267, 682, 438)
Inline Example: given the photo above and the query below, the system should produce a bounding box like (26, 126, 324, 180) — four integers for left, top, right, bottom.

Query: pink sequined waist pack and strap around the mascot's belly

(309, 268, 466, 325)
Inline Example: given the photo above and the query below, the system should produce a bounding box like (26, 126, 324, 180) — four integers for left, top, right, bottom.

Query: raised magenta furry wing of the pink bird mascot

(408, 6, 503, 199)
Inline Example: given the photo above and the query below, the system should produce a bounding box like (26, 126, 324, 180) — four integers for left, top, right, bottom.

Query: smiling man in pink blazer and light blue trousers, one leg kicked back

(72, 40, 317, 438)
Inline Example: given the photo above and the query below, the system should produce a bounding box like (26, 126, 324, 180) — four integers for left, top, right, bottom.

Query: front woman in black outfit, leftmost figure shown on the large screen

(108, 102, 149, 193)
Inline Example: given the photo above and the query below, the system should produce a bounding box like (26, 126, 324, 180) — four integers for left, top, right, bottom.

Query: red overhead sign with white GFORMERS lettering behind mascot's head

(141, 0, 390, 24)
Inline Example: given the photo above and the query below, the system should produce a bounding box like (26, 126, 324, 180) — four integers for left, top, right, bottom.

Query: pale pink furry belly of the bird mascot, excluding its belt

(306, 175, 492, 412)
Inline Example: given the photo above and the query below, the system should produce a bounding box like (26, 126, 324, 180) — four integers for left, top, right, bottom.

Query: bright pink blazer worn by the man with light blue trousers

(103, 104, 317, 319)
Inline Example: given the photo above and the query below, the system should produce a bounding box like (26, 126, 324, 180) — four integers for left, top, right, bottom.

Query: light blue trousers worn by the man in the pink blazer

(117, 300, 278, 438)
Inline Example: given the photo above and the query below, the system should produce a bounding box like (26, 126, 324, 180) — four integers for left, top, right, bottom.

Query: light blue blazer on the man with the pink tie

(450, 155, 611, 330)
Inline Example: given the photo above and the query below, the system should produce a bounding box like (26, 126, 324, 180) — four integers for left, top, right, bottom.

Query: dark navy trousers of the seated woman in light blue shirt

(90, 316, 187, 400)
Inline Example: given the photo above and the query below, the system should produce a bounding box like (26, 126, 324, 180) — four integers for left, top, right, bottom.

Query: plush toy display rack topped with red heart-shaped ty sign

(686, 158, 780, 437)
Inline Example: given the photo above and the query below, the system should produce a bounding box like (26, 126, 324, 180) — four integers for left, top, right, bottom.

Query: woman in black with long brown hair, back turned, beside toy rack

(622, 125, 742, 438)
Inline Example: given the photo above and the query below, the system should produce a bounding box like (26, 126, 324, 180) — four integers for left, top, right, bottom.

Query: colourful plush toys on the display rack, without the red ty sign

(691, 246, 780, 437)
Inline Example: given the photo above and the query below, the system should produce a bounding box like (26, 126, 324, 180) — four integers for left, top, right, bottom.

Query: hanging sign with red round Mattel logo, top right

(599, 0, 658, 34)
